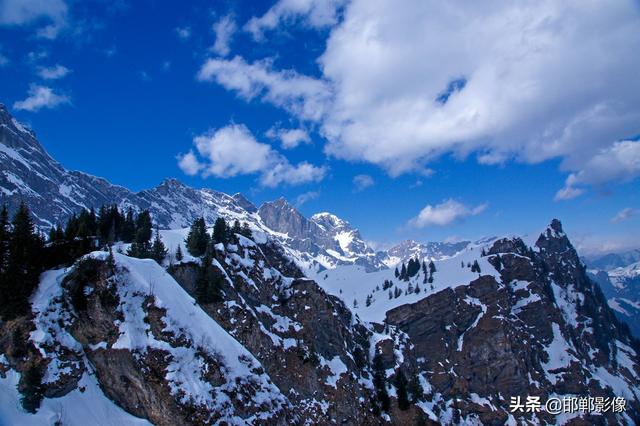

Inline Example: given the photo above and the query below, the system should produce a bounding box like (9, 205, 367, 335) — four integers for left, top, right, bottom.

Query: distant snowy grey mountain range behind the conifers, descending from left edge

(0, 104, 468, 271)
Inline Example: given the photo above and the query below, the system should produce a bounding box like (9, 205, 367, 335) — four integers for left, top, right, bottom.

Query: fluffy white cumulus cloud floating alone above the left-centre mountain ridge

(177, 124, 326, 187)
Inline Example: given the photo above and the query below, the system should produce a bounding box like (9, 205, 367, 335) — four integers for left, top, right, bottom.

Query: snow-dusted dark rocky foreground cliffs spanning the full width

(0, 221, 640, 424)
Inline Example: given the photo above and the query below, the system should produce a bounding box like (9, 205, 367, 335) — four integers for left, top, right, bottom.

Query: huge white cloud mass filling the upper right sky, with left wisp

(200, 0, 640, 195)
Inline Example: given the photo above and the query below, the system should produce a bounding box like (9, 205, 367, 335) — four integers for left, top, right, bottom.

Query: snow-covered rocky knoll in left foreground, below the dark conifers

(0, 252, 289, 425)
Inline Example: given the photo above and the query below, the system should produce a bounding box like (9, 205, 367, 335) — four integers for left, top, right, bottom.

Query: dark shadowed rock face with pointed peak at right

(386, 220, 640, 423)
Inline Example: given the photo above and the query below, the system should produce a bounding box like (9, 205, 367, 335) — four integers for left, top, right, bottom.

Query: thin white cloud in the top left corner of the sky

(0, 0, 68, 39)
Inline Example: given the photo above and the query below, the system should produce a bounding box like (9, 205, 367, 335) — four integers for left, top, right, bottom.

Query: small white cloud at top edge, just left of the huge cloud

(244, 0, 345, 40)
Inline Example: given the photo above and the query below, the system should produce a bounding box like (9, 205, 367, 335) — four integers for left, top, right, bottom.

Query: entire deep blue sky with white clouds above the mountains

(0, 0, 640, 252)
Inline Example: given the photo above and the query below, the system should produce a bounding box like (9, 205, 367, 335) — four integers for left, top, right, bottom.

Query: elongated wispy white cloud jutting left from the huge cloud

(198, 56, 330, 120)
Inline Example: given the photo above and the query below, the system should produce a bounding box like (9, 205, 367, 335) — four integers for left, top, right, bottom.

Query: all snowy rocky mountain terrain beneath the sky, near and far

(0, 108, 640, 425)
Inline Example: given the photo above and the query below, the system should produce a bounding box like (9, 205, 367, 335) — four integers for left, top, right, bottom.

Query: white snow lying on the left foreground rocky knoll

(20, 252, 288, 424)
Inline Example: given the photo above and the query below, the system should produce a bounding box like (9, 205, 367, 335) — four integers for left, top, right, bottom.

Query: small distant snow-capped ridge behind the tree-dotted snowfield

(380, 240, 471, 268)
